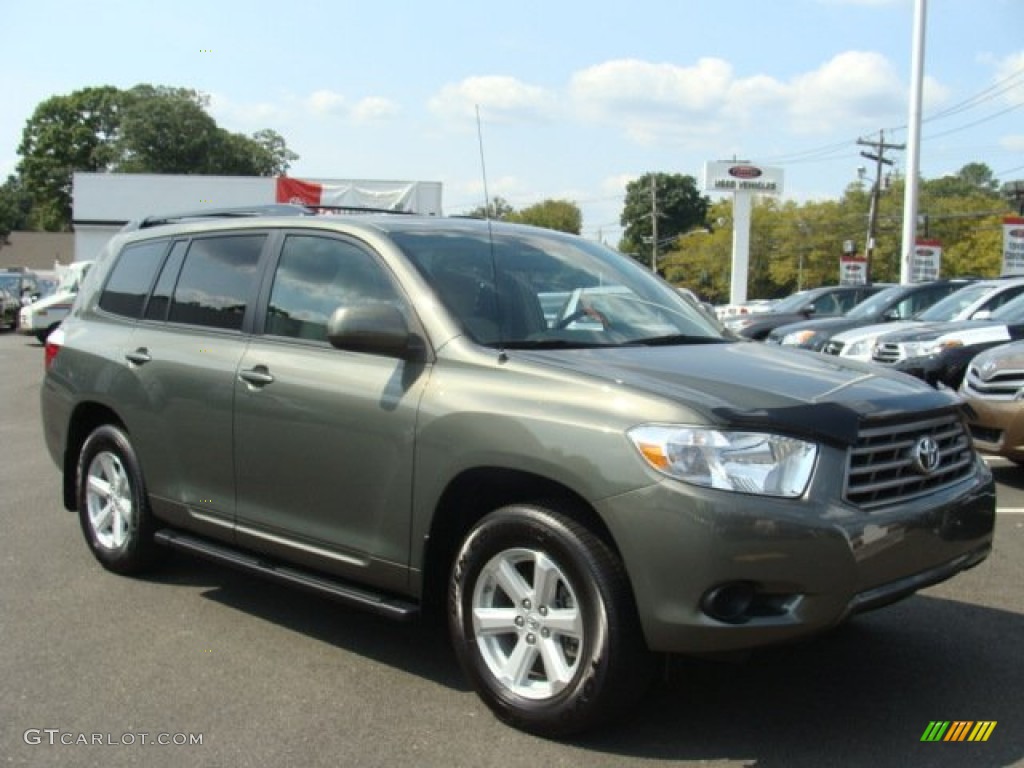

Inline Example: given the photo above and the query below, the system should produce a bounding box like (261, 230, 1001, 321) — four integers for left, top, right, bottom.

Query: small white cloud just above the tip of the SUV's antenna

(430, 75, 557, 122)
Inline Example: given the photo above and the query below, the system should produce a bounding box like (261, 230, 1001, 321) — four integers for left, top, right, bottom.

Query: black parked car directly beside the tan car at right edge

(871, 296, 1024, 389)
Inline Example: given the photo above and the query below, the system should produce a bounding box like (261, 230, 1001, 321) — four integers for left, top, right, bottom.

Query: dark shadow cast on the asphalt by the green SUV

(142, 557, 1024, 768)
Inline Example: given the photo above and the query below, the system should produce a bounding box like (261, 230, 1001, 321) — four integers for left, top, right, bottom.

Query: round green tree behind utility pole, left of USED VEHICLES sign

(618, 173, 711, 263)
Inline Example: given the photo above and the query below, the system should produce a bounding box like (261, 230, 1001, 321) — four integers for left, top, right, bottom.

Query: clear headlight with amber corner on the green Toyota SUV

(628, 425, 818, 499)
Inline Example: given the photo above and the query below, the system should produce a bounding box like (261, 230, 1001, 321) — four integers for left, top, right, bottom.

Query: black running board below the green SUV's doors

(153, 528, 420, 622)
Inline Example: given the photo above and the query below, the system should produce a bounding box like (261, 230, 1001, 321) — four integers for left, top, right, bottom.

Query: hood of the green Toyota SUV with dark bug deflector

(510, 342, 958, 445)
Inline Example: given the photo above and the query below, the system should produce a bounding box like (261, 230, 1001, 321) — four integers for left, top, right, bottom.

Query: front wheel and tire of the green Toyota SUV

(449, 506, 653, 736)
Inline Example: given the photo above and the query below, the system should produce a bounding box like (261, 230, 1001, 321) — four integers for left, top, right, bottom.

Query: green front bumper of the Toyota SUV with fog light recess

(599, 459, 995, 653)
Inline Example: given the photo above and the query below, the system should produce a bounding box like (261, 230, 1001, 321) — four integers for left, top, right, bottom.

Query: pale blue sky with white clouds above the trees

(0, 0, 1024, 240)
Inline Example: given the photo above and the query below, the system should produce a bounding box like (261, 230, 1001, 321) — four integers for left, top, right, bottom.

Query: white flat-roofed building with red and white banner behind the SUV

(72, 173, 441, 261)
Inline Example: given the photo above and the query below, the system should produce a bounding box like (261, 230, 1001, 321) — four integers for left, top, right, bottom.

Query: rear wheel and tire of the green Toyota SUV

(77, 424, 157, 573)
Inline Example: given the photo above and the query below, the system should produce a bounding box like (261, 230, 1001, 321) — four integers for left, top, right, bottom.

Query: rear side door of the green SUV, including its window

(126, 231, 267, 539)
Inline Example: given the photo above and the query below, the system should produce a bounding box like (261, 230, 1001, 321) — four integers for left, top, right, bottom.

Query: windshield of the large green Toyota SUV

(391, 226, 725, 348)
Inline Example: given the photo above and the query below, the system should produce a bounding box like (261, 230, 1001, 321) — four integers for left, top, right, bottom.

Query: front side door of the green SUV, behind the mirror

(233, 230, 428, 589)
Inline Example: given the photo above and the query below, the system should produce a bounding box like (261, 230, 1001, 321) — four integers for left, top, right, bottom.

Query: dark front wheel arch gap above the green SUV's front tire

(421, 467, 622, 612)
